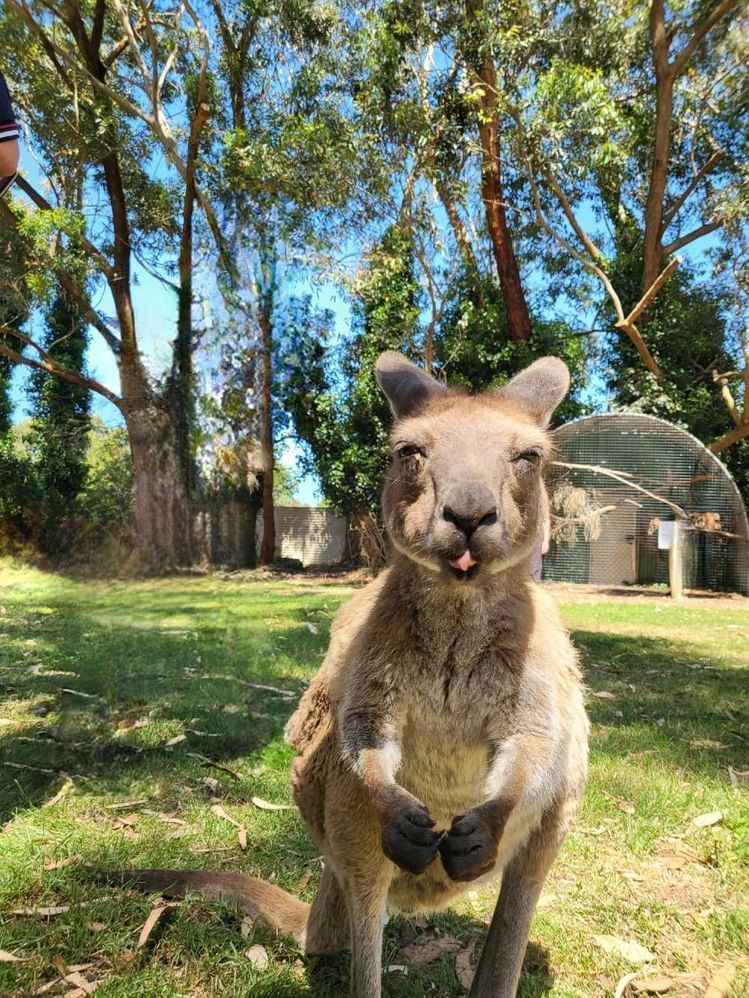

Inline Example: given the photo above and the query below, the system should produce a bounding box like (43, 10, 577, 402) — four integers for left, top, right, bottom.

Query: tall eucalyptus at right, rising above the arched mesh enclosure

(500, 0, 749, 452)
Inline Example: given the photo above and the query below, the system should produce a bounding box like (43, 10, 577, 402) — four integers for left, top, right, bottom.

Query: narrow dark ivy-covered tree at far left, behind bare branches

(29, 292, 91, 555)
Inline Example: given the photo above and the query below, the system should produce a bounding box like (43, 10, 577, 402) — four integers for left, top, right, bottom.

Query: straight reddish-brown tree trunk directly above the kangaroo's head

(476, 58, 533, 340)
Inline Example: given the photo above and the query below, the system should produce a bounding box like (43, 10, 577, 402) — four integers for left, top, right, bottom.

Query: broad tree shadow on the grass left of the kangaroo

(0, 590, 327, 823)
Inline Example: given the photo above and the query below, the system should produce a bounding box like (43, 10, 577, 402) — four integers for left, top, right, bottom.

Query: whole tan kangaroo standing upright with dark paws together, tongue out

(102, 352, 588, 998)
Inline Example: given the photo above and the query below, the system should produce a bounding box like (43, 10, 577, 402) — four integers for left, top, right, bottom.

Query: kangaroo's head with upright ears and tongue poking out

(377, 353, 569, 582)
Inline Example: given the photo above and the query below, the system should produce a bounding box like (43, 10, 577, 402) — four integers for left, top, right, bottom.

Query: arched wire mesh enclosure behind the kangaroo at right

(543, 413, 749, 594)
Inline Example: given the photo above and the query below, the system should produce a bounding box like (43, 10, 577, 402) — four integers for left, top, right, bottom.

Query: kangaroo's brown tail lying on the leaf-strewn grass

(96, 870, 311, 946)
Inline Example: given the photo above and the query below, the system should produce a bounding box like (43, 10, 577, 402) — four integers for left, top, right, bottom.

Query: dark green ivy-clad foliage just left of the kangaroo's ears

(285, 226, 419, 519)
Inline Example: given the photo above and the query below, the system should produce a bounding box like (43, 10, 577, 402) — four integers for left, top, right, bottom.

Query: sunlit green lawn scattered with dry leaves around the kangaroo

(0, 562, 749, 998)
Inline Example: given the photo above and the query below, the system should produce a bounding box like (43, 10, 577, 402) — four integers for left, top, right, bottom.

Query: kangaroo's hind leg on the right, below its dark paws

(469, 808, 567, 998)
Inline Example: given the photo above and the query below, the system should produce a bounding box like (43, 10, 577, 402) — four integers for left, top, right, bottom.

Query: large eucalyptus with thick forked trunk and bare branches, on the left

(0, 0, 219, 570)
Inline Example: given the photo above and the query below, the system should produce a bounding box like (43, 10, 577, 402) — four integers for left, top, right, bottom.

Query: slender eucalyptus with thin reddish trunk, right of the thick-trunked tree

(199, 0, 373, 563)
